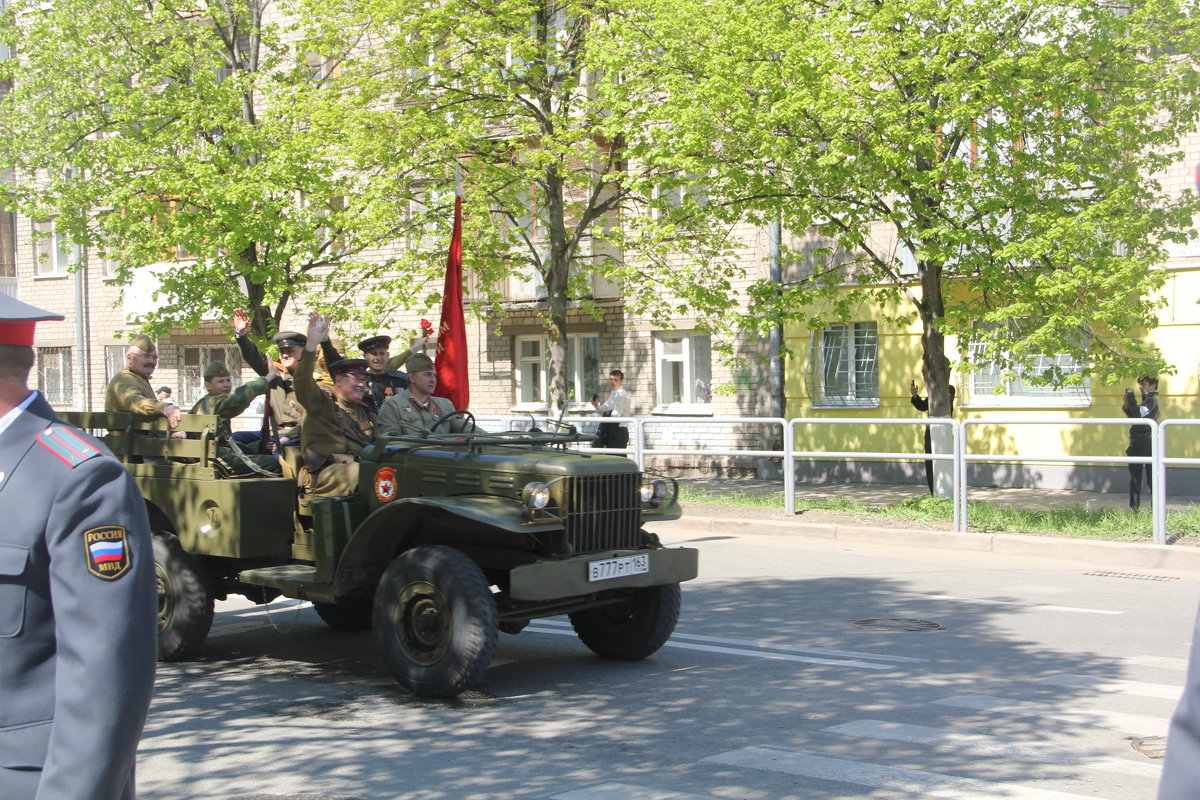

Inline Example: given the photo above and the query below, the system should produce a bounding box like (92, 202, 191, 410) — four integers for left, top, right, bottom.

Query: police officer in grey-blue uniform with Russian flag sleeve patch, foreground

(0, 295, 157, 800)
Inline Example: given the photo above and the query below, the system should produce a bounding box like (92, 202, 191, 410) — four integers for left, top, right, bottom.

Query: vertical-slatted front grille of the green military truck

(566, 473, 642, 553)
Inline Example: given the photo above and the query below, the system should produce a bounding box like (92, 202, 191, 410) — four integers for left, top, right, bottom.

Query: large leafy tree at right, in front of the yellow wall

(600, 0, 1200, 416)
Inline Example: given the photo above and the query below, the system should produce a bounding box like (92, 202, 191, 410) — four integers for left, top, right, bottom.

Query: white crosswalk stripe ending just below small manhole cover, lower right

(826, 720, 1163, 778)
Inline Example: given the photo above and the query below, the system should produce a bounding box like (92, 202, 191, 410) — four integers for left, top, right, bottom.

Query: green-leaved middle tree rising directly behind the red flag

(306, 0, 732, 407)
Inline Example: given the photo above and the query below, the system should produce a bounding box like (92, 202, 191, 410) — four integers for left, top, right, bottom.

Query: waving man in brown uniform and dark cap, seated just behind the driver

(295, 313, 376, 512)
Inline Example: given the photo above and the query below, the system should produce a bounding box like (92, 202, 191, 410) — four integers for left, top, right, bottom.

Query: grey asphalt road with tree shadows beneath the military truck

(138, 527, 1200, 800)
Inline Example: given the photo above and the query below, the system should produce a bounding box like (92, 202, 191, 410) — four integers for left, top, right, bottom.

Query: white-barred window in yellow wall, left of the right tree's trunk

(804, 323, 880, 408)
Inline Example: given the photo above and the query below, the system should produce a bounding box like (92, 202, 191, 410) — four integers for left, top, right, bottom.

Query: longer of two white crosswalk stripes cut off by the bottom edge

(702, 747, 1096, 800)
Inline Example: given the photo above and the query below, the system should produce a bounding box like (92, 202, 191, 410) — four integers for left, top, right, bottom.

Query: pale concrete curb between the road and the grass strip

(650, 516, 1200, 572)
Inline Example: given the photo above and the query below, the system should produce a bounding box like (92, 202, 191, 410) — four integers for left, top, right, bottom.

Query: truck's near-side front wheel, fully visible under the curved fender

(374, 546, 498, 697)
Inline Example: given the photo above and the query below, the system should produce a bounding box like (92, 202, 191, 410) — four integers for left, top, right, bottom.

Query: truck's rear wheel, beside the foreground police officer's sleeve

(154, 530, 212, 661)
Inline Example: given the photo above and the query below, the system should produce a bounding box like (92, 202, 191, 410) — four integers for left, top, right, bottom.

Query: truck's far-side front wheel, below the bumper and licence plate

(570, 583, 679, 661)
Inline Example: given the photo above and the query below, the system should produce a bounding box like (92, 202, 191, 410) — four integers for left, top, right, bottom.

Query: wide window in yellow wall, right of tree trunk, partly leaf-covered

(967, 331, 1092, 408)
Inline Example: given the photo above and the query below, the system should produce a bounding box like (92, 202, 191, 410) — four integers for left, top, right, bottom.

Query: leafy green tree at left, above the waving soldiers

(0, 0, 449, 336)
